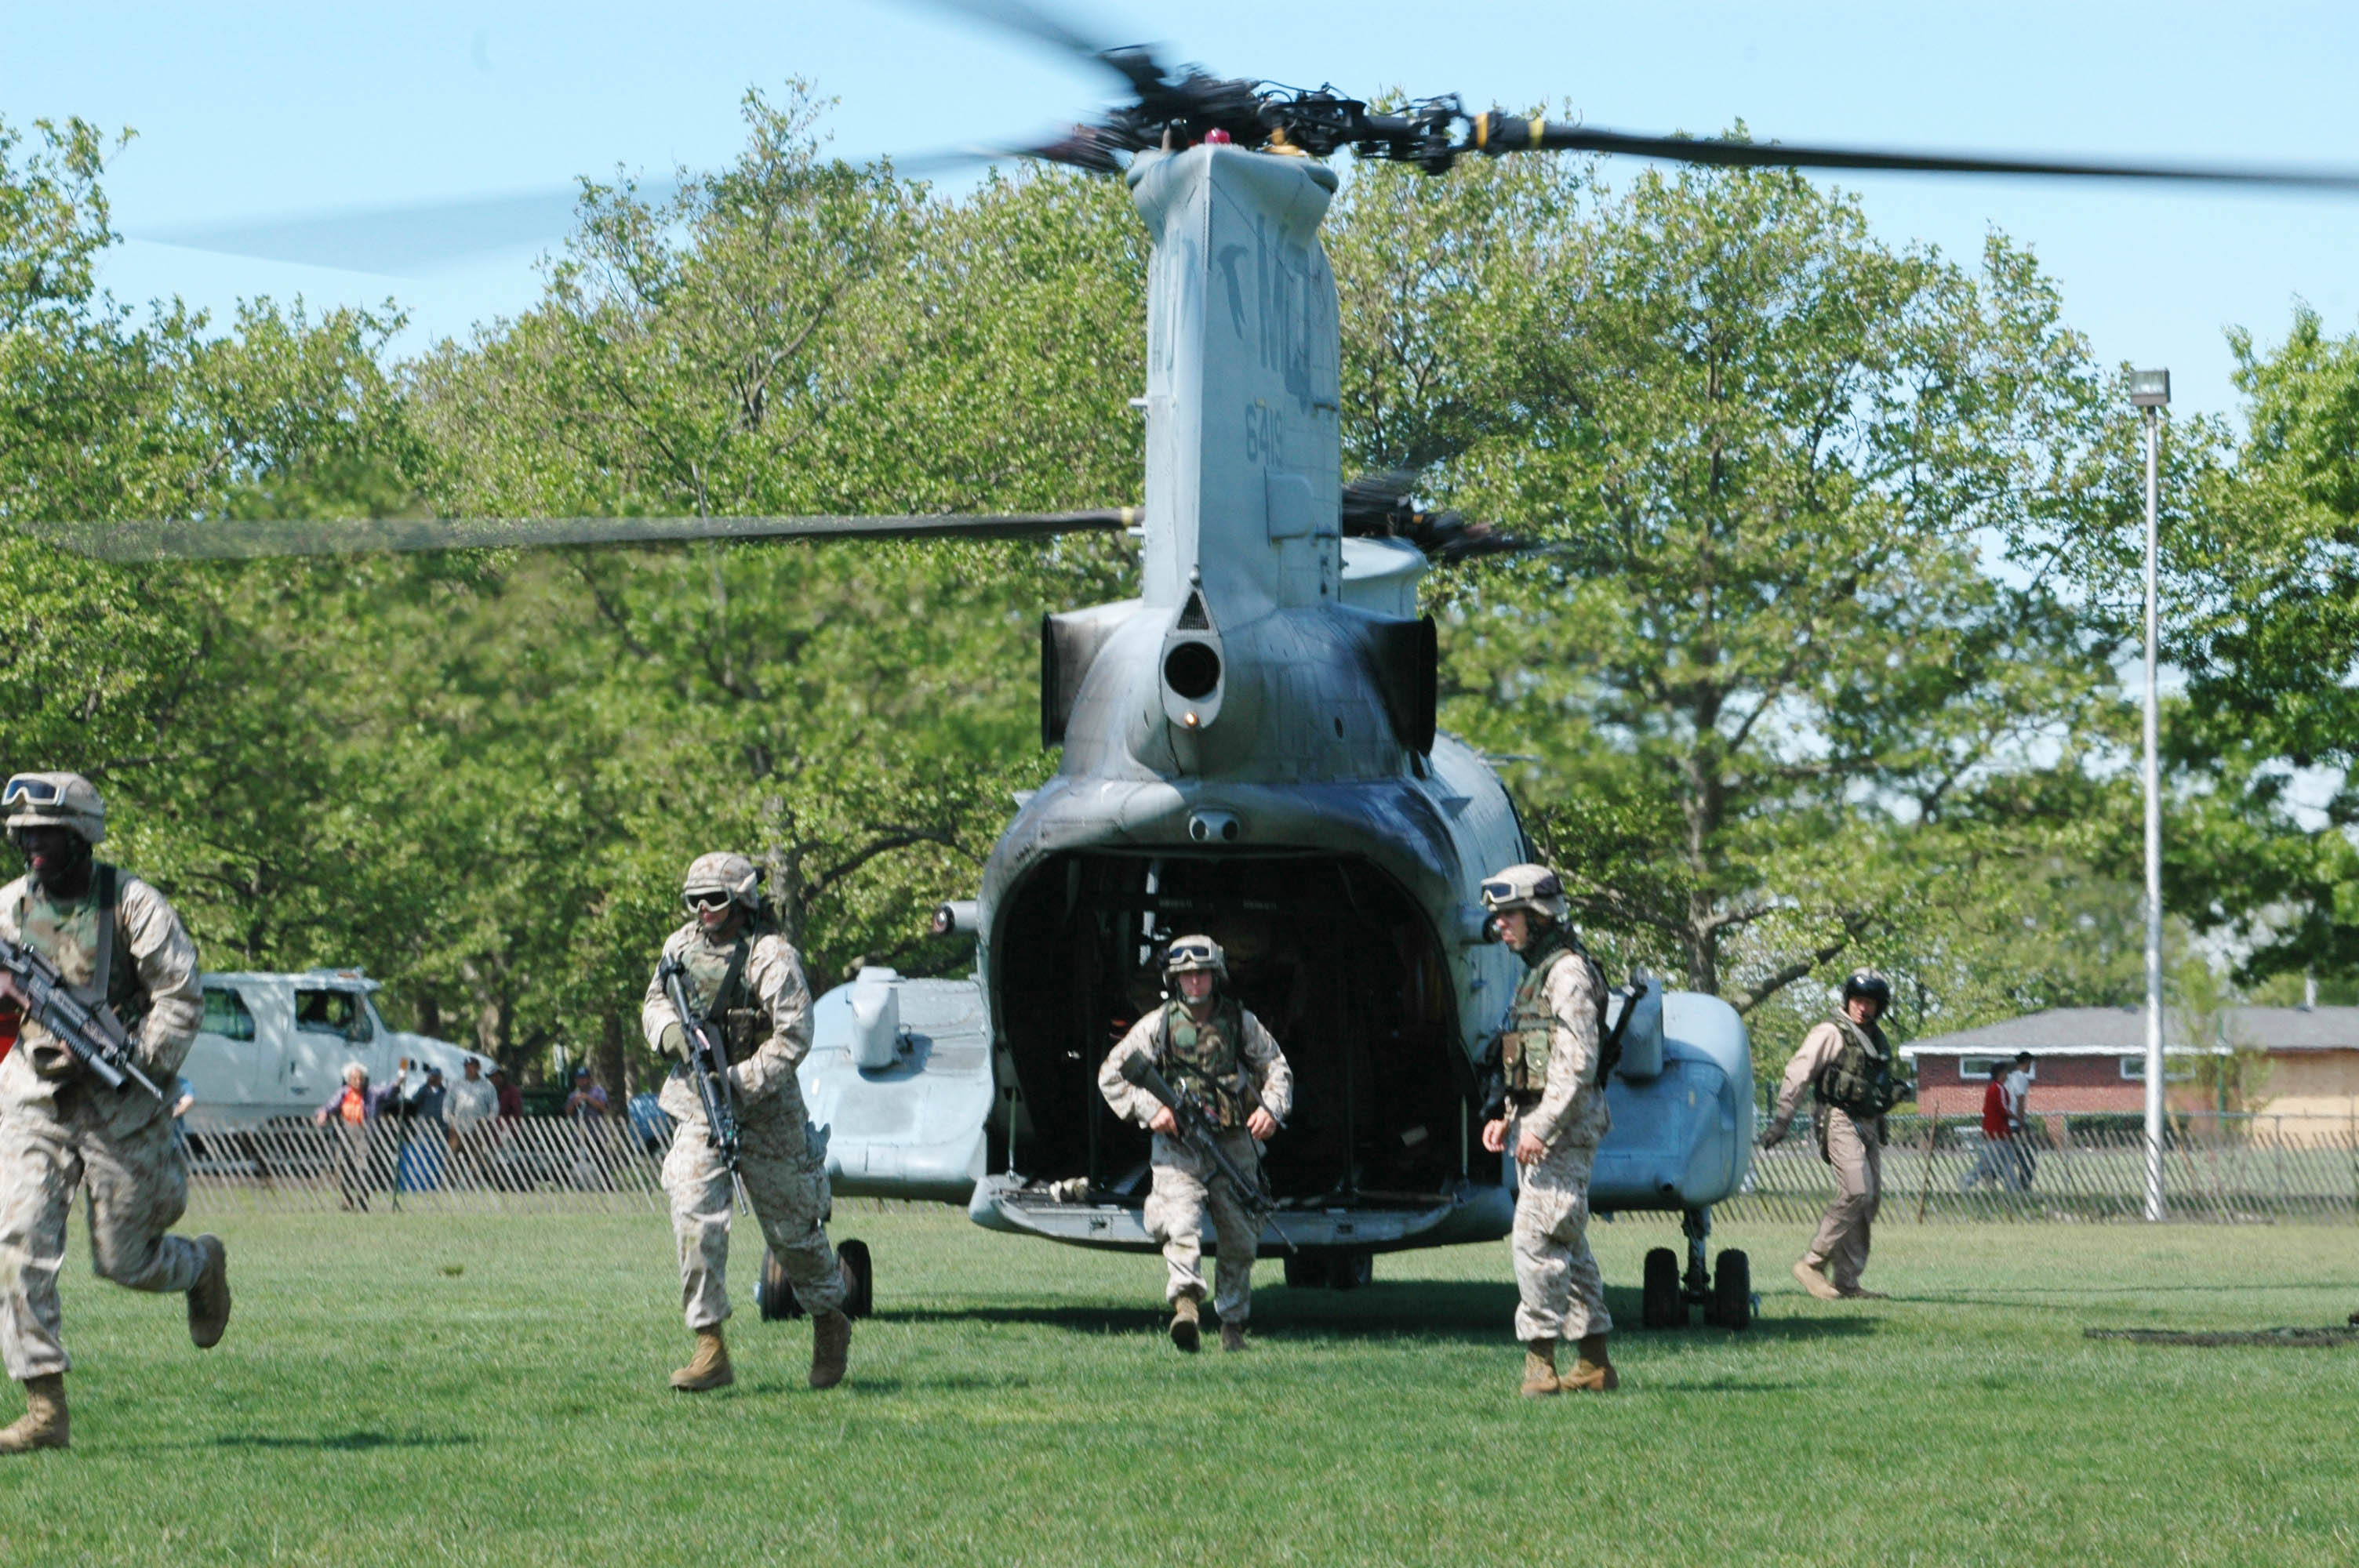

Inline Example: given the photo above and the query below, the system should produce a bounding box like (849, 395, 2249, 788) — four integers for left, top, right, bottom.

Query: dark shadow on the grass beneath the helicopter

(878, 1280, 1875, 1351)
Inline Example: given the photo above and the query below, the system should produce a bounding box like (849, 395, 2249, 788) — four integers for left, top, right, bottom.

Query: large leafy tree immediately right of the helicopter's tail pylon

(1336, 149, 2114, 1037)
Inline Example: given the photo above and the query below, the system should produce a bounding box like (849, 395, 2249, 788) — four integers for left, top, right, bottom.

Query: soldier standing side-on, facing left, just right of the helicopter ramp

(1481, 866, 1620, 1398)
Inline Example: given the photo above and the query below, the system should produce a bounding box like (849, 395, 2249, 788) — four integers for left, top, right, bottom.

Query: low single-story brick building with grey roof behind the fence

(1901, 1007, 2359, 1125)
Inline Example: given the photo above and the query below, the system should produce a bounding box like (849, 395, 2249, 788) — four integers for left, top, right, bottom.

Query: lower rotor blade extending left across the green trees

(21, 507, 1140, 561)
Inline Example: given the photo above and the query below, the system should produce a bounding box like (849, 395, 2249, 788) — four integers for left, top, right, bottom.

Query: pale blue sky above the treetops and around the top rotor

(0, 0, 2359, 422)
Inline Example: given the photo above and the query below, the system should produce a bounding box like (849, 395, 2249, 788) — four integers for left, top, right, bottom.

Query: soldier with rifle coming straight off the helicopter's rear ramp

(1097, 936, 1295, 1351)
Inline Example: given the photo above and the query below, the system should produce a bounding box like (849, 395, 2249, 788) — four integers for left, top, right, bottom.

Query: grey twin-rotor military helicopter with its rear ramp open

(45, 5, 2359, 1327)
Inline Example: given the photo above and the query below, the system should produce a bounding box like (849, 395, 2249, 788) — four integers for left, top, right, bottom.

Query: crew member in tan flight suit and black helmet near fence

(1762, 969, 1908, 1301)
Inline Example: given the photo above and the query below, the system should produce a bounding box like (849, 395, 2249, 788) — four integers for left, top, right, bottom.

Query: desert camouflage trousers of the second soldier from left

(663, 1102, 845, 1330)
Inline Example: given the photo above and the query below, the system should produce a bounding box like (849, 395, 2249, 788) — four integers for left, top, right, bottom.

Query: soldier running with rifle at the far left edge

(0, 773, 229, 1453)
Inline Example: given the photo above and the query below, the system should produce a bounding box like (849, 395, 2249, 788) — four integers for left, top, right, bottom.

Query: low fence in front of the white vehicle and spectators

(189, 1116, 667, 1212)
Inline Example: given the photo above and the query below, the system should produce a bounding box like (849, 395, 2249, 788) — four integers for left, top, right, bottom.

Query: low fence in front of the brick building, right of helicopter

(1717, 1113, 2359, 1224)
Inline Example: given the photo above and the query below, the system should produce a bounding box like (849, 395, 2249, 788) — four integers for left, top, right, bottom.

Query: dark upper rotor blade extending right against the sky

(1470, 113, 2359, 191)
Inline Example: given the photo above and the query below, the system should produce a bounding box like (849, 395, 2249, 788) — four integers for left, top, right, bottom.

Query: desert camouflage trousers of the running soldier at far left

(0, 1089, 205, 1381)
